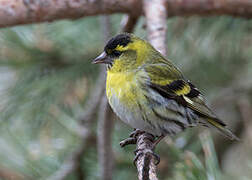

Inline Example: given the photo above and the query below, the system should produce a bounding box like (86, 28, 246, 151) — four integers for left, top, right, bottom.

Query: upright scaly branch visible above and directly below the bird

(123, 0, 167, 180)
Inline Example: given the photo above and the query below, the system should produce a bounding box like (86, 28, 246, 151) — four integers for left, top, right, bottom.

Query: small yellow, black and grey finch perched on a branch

(92, 33, 239, 145)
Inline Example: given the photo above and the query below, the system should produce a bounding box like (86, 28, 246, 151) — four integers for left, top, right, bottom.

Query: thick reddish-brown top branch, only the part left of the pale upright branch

(0, 0, 141, 27)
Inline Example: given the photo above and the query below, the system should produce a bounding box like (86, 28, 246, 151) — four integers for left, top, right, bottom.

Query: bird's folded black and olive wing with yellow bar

(140, 62, 225, 126)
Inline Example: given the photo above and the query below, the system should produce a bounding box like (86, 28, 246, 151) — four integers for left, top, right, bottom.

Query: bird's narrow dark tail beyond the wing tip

(207, 118, 240, 141)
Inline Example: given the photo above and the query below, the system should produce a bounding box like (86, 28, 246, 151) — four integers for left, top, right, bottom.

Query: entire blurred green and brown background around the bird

(0, 15, 252, 180)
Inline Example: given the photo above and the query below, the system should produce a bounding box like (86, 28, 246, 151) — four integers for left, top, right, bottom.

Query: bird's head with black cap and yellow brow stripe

(93, 33, 155, 72)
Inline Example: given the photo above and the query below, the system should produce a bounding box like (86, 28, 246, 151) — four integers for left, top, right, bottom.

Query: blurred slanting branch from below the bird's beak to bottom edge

(48, 69, 105, 180)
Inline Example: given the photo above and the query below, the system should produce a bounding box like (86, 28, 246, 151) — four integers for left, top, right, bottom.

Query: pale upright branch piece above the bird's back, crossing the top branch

(143, 0, 167, 56)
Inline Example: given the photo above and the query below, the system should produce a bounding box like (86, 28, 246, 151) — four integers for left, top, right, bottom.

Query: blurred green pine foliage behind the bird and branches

(0, 15, 252, 180)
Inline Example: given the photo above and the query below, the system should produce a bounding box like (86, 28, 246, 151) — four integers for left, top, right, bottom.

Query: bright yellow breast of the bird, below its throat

(106, 71, 138, 106)
